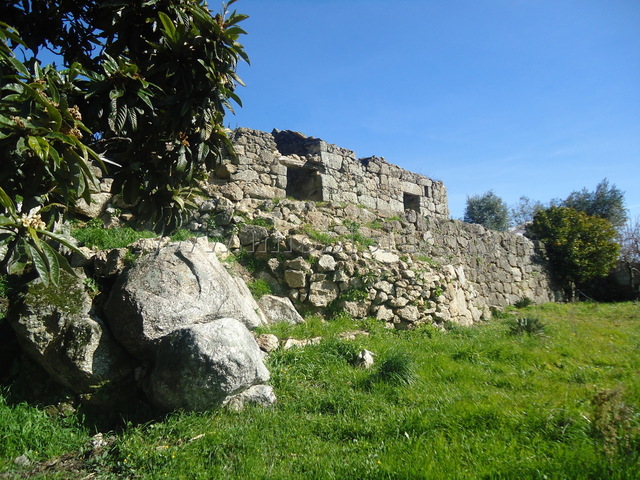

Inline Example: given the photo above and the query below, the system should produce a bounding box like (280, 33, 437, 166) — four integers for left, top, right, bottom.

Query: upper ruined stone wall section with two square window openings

(216, 128, 449, 219)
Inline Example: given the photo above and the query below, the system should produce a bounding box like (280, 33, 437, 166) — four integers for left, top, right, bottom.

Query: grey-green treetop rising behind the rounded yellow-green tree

(561, 178, 627, 227)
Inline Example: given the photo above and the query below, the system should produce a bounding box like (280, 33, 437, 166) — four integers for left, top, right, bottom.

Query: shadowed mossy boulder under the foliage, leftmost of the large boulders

(11, 272, 132, 393)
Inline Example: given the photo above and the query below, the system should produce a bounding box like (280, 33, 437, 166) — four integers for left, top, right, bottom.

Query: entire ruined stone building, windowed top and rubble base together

(192, 128, 555, 328)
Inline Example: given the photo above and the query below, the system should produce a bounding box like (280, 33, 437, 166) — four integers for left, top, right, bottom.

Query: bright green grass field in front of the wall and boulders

(0, 303, 640, 480)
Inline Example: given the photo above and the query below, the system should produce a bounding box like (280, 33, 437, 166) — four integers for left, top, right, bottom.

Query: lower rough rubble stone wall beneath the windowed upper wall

(184, 191, 554, 328)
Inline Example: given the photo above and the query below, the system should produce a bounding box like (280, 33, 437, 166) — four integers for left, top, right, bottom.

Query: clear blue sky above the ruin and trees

(224, 0, 640, 218)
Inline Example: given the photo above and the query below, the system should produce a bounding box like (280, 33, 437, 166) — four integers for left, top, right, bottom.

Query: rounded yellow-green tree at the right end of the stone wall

(527, 207, 620, 298)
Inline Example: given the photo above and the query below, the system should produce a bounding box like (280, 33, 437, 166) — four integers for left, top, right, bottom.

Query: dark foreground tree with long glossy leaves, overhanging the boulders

(0, 0, 248, 284)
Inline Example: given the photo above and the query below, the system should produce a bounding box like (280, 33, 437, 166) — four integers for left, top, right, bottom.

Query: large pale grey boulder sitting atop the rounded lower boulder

(104, 239, 266, 359)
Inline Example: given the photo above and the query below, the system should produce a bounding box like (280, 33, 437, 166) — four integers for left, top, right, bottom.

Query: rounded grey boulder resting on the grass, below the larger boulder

(145, 318, 275, 411)
